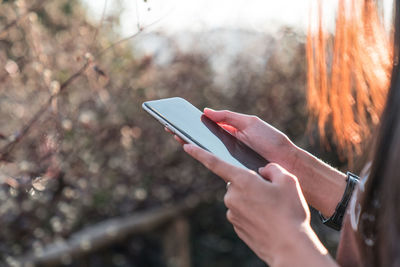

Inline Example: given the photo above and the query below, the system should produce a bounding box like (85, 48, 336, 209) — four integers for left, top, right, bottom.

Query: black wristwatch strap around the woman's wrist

(319, 172, 360, 231)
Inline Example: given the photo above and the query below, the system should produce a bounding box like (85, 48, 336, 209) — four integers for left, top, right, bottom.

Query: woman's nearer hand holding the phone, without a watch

(184, 144, 333, 266)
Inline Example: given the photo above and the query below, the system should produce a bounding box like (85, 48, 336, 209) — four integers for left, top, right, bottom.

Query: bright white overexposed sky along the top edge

(83, 0, 336, 35)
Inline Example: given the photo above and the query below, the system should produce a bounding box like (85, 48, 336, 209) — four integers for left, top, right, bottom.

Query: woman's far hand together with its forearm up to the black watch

(166, 108, 346, 217)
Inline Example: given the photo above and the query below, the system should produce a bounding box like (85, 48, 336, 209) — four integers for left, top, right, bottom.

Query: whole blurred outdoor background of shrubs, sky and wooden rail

(0, 0, 356, 267)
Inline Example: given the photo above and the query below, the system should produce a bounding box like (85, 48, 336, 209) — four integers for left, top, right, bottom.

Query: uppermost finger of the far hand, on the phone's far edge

(204, 108, 250, 130)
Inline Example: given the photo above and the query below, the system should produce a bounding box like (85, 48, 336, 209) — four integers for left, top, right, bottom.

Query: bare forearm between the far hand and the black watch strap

(291, 145, 346, 217)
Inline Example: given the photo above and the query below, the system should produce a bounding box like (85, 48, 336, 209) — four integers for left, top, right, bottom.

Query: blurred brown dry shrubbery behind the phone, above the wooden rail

(0, 0, 326, 266)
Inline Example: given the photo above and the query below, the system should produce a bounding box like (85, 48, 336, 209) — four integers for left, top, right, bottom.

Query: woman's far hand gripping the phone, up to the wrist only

(204, 108, 296, 172)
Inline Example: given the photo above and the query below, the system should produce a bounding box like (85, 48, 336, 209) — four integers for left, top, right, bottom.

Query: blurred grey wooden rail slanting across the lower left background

(18, 194, 209, 266)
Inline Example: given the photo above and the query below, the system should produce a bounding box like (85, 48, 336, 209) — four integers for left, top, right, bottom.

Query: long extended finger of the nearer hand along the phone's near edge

(183, 144, 242, 184)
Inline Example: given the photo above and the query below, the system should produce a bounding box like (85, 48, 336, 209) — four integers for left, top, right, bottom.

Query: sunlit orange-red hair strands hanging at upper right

(306, 0, 392, 161)
